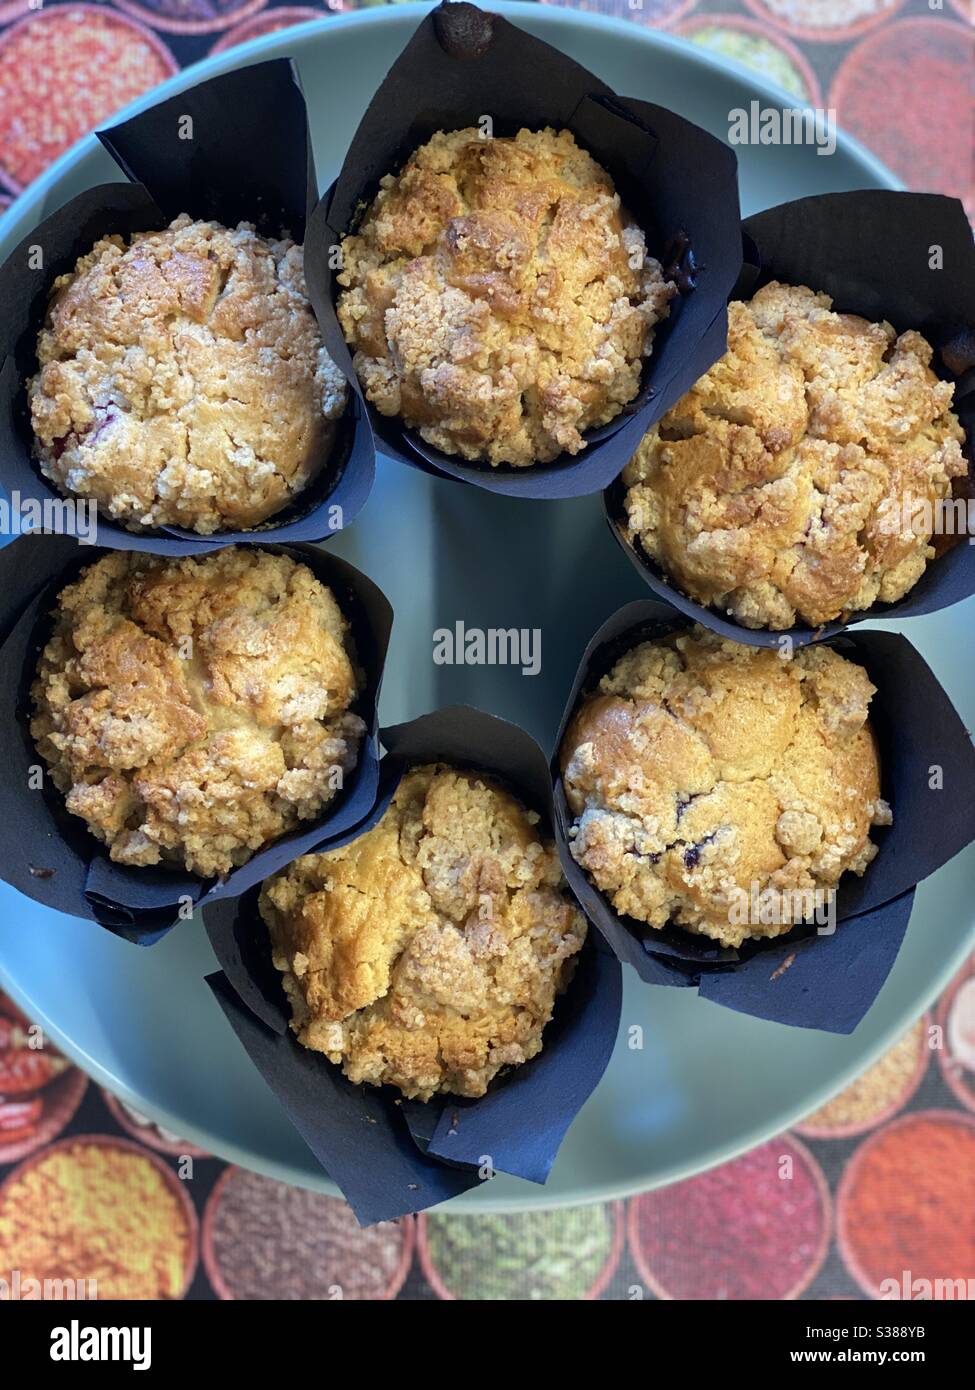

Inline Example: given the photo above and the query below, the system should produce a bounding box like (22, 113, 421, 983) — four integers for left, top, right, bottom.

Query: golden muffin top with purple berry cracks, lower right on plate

(561, 627, 892, 947)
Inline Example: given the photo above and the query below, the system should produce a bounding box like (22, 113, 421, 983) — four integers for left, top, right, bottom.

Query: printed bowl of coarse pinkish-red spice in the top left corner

(0, 4, 177, 193)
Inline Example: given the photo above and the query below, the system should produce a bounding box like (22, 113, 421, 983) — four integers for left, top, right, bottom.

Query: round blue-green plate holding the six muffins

(0, 4, 975, 1211)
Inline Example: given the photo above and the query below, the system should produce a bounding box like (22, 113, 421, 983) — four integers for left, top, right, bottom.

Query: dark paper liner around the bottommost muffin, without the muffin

(203, 705, 622, 1226)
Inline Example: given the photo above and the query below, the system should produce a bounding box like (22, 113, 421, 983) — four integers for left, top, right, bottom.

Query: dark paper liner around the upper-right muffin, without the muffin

(604, 189, 975, 646)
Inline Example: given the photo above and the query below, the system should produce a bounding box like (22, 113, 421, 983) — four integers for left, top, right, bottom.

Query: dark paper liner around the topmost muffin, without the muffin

(306, 3, 741, 498)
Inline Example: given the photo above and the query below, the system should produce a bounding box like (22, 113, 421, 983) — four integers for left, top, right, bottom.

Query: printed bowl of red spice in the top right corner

(829, 19, 975, 207)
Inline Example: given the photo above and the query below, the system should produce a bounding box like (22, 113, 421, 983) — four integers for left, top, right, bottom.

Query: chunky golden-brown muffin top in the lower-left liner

(31, 546, 366, 877)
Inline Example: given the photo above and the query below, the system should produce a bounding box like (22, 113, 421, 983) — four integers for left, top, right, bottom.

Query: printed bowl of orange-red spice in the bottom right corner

(836, 1111, 975, 1298)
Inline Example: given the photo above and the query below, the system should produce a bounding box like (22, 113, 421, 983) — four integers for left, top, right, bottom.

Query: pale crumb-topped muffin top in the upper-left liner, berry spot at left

(28, 215, 348, 535)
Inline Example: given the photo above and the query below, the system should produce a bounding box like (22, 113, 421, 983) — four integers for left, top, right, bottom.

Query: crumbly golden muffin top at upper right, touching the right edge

(623, 282, 967, 630)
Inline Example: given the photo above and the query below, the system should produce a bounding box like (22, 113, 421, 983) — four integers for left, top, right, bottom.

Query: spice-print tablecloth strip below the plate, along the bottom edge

(0, 956, 975, 1301)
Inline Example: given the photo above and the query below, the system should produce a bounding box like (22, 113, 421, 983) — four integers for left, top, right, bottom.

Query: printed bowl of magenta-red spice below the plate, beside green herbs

(627, 1134, 830, 1302)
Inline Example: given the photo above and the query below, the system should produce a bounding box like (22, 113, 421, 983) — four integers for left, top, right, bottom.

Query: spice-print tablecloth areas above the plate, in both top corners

(0, 0, 975, 205)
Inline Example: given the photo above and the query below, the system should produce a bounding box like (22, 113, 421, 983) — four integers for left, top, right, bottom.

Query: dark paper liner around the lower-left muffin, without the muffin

(0, 537, 392, 945)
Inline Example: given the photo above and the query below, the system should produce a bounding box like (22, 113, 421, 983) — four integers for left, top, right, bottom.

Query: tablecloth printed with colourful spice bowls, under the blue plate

(0, 0, 975, 1298)
